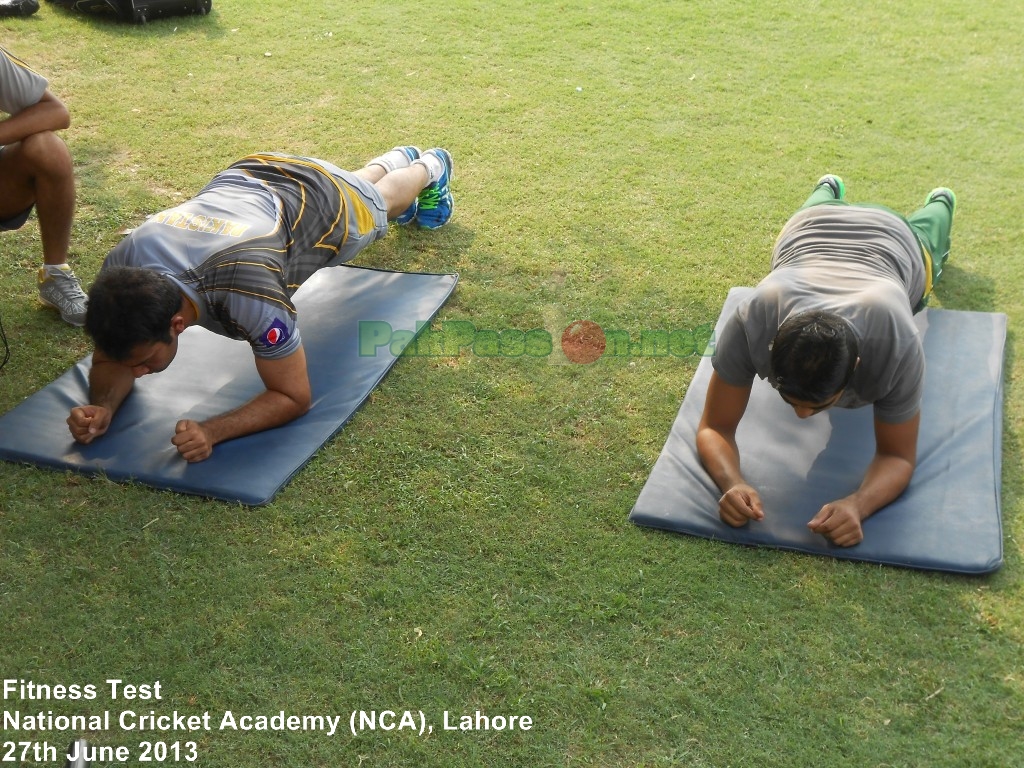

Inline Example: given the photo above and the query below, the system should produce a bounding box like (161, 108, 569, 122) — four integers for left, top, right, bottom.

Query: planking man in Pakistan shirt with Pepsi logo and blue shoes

(68, 146, 454, 462)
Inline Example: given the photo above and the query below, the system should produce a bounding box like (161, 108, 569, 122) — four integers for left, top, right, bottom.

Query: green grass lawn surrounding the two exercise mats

(0, 0, 1024, 768)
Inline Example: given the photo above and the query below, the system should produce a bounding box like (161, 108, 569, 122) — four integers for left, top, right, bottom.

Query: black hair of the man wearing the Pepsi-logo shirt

(85, 266, 181, 360)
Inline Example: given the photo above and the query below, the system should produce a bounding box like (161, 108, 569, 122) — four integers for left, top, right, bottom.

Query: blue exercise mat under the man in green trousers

(630, 288, 1007, 574)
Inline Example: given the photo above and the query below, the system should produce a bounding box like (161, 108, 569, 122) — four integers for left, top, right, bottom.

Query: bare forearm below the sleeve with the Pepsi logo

(171, 347, 312, 462)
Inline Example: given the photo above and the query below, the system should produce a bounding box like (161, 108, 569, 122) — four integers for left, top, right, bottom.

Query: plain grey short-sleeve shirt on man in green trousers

(713, 205, 925, 424)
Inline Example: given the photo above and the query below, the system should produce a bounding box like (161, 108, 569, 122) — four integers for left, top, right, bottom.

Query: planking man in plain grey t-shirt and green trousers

(696, 174, 956, 547)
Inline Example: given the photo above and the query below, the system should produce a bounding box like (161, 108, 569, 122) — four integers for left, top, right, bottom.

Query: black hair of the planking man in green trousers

(771, 310, 858, 403)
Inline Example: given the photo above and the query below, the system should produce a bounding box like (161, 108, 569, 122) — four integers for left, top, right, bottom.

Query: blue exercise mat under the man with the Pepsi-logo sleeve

(0, 266, 458, 505)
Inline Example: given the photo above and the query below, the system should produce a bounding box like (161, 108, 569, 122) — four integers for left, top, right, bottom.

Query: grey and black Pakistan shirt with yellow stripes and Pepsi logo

(104, 154, 387, 358)
